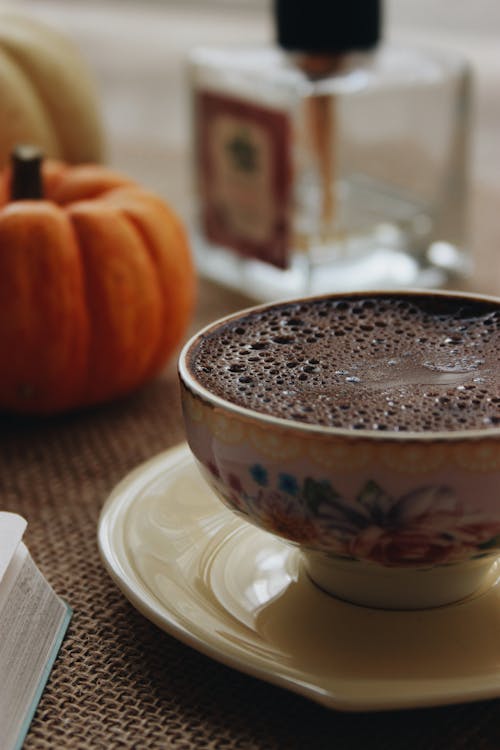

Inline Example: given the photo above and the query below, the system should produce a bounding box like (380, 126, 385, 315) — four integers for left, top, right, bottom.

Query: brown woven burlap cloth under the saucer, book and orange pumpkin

(0, 284, 500, 750)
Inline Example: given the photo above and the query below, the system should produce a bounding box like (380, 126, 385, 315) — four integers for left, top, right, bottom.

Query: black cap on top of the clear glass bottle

(274, 0, 381, 53)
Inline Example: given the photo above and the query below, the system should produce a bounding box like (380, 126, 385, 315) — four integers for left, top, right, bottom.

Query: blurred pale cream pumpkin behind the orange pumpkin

(0, 7, 103, 168)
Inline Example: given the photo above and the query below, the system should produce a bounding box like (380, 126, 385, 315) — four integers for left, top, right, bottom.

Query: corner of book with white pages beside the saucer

(0, 511, 71, 750)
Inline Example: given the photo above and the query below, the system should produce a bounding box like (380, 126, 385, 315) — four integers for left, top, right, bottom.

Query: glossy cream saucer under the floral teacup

(98, 445, 500, 710)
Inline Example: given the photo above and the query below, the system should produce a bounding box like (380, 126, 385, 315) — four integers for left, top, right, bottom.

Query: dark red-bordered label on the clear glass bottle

(196, 92, 292, 268)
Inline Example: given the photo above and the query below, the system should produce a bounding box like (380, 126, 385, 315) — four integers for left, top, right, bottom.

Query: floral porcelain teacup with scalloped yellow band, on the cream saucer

(179, 292, 500, 609)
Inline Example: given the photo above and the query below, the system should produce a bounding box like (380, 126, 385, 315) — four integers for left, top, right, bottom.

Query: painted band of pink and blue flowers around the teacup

(202, 462, 500, 567)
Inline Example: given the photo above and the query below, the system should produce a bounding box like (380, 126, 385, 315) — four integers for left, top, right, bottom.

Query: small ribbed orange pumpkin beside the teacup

(0, 149, 195, 414)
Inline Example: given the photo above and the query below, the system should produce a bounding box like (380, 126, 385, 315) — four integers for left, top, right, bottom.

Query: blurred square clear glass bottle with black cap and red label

(189, 0, 471, 300)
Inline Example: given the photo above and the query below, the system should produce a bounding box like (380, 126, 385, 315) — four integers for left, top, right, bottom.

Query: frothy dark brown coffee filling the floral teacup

(190, 293, 500, 432)
